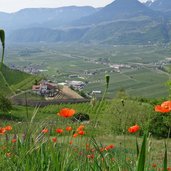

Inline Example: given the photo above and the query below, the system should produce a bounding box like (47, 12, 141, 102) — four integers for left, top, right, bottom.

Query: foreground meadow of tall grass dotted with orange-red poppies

(0, 81, 171, 171)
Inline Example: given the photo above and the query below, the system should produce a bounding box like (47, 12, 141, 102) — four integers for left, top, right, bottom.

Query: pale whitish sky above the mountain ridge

(0, 0, 146, 12)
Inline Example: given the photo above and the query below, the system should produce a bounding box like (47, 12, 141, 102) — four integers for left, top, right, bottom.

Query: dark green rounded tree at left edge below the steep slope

(0, 95, 12, 113)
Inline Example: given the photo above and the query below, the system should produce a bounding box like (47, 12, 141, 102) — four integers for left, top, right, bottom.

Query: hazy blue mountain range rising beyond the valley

(0, 0, 171, 44)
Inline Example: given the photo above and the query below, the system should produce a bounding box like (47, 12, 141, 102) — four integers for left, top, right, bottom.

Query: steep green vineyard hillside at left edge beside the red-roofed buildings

(0, 65, 40, 95)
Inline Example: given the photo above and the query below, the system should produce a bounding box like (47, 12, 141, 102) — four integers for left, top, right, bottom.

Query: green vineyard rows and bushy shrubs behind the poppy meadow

(4, 100, 154, 135)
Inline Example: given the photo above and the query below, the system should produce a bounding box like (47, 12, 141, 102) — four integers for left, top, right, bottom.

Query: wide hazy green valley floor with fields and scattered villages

(5, 43, 171, 98)
